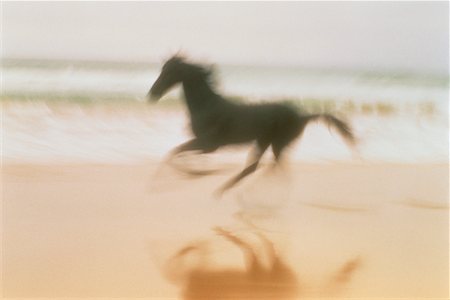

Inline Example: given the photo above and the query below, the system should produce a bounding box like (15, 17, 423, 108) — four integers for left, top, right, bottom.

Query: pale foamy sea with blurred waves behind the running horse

(2, 60, 449, 163)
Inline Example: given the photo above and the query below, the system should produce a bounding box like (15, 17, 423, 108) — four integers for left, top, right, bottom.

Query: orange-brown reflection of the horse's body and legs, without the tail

(165, 228, 299, 300)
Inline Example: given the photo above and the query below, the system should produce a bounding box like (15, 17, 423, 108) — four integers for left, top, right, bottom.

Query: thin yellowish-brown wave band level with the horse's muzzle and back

(0, 92, 446, 117)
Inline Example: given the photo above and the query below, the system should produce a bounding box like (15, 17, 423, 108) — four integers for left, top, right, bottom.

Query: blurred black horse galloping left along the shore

(148, 56, 355, 192)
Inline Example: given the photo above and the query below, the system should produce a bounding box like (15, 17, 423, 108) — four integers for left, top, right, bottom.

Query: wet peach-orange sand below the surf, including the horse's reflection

(2, 161, 449, 299)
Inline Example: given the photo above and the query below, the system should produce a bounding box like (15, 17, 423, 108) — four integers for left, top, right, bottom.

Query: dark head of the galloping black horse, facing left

(147, 56, 187, 101)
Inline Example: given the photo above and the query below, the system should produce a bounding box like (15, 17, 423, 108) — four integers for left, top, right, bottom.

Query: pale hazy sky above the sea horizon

(2, 1, 449, 74)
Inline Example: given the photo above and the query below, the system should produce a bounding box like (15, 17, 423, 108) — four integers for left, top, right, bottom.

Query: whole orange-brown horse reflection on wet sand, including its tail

(158, 227, 362, 300)
